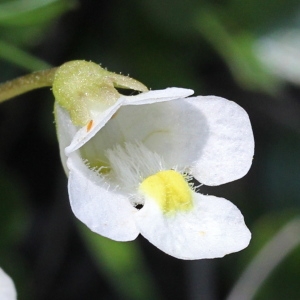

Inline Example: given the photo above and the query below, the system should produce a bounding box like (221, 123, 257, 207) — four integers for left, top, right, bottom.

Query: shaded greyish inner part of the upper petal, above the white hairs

(89, 99, 207, 171)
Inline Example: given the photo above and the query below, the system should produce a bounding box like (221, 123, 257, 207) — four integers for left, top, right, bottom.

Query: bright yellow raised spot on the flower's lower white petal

(140, 170, 193, 214)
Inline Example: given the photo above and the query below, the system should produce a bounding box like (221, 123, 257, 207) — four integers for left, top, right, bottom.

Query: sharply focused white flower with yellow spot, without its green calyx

(55, 88, 254, 259)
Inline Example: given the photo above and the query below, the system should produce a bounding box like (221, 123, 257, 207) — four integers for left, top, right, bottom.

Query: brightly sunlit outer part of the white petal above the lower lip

(184, 96, 254, 185)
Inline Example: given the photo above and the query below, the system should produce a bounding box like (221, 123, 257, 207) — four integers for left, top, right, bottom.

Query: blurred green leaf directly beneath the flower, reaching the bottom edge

(79, 224, 160, 300)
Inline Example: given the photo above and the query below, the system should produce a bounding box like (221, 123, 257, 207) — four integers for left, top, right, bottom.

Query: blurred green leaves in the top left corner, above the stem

(0, 0, 77, 71)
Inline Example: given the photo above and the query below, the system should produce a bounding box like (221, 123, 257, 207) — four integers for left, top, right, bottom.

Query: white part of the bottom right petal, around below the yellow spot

(136, 193, 251, 259)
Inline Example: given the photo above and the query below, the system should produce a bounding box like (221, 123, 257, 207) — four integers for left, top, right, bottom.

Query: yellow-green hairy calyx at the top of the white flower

(53, 60, 147, 126)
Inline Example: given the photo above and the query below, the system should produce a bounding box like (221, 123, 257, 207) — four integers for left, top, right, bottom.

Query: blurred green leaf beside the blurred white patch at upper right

(196, 8, 280, 94)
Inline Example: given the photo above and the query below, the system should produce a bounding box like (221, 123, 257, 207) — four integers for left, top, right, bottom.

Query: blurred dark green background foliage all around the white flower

(0, 0, 300, 300)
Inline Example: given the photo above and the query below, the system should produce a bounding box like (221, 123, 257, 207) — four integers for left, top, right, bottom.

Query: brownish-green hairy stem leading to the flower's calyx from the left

(0, 68, 57, 103)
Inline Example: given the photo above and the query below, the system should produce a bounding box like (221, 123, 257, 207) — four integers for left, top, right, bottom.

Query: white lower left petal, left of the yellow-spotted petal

(67, 152, 139, 241)
